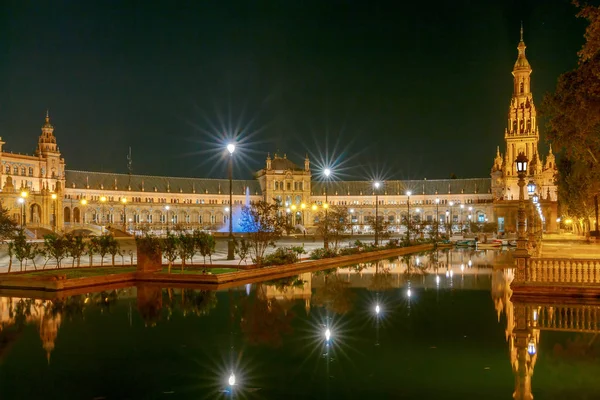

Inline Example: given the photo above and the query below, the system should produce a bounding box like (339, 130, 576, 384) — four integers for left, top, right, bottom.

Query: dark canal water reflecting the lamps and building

(0, 250, 600, 400)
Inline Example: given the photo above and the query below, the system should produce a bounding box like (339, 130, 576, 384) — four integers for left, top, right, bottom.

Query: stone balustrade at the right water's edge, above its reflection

(525, 258, 600, 286)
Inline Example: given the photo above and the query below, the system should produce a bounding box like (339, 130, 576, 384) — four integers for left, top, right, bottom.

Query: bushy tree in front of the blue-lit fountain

(240, 201, 285, 265)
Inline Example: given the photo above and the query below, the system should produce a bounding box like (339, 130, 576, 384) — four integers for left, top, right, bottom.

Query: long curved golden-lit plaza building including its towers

(0, 31, 557, 236)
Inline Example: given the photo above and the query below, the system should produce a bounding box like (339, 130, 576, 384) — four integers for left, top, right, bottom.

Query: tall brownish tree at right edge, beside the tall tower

(541, 2, 600, 230)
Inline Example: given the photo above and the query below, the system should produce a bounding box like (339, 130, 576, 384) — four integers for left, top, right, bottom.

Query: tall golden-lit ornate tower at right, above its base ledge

(491, 26, 556, 201)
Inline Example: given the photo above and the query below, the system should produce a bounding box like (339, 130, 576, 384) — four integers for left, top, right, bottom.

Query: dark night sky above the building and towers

(0, 0, 585, 179)
